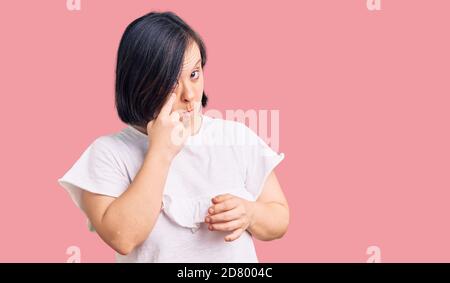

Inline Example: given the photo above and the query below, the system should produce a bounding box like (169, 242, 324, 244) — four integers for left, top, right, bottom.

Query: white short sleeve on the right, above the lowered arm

(244, 125, 284, 200)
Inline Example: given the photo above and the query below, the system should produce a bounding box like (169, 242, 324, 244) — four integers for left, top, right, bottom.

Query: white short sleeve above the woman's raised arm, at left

(58, 137, 130, 231)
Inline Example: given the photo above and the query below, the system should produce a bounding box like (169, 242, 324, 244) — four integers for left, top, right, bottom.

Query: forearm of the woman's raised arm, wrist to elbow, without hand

(100, 153, 170, 253)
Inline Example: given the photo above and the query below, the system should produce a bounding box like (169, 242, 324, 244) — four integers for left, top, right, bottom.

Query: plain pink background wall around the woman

(0, 0, 450, 262)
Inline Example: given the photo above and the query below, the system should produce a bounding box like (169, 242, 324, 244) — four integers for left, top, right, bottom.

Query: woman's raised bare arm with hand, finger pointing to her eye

(82, 92, 188, 255)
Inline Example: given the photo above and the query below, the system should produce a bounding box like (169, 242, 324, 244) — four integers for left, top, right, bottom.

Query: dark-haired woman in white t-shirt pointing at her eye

(58, 12, 289, 262)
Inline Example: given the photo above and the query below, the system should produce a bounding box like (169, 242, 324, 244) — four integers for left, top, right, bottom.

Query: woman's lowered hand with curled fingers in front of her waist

(205, 194, 254, 242)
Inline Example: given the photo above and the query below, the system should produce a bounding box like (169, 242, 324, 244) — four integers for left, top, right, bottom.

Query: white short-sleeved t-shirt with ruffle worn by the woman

(58, 115, 284, 262)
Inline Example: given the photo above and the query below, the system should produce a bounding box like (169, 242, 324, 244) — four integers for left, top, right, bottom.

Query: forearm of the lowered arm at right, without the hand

(247, 201, 289, 241)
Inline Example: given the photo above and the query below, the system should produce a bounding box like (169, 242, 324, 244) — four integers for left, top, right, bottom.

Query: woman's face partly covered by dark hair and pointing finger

(172, 43, 203, 125)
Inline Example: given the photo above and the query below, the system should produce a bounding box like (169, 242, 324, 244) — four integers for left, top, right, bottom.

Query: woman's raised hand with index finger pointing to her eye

(147, 93, 190, 161)
